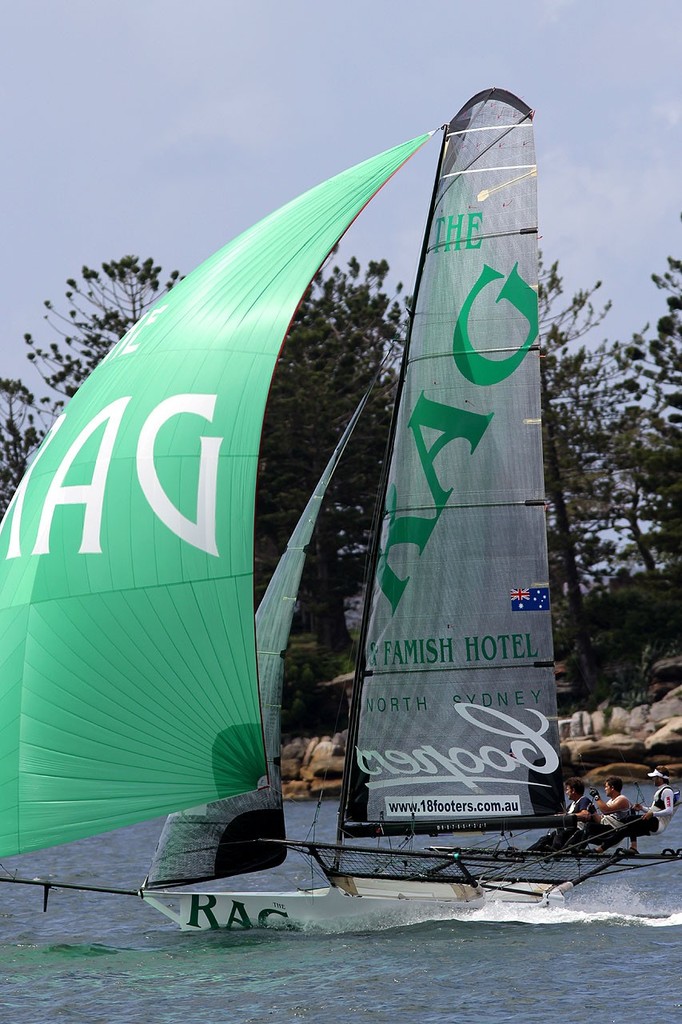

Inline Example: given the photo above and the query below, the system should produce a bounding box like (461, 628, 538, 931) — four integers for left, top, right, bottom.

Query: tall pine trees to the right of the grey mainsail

(540, 239, 682, 693)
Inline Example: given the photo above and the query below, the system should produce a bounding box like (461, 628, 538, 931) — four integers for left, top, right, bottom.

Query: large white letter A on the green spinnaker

(33, 396, 130, 555)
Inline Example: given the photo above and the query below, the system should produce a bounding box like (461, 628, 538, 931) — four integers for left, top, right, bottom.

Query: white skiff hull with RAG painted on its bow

(142, 883, 485, 932)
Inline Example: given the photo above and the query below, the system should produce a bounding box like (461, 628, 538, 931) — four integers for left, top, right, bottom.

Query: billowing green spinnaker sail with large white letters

(0, 135, 429, 856)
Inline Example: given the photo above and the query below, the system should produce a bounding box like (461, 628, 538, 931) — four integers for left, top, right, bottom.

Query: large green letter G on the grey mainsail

(453, 263, 539, 385)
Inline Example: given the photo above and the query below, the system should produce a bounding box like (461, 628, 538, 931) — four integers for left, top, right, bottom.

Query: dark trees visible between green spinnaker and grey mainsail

(257, 259, 401, 650)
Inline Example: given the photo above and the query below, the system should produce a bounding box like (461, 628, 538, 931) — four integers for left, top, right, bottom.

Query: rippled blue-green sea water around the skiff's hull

(0, 803, 682, 1024)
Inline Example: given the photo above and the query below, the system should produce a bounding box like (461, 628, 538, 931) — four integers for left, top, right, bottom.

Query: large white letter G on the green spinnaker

(137, 394, 222, 555)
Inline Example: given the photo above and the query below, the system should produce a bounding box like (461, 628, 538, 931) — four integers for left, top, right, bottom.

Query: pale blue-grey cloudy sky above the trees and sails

(0, 0, 682, 386)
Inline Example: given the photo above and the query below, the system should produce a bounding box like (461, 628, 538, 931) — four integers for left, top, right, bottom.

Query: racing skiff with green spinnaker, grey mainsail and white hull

(0, 89, 678, 931)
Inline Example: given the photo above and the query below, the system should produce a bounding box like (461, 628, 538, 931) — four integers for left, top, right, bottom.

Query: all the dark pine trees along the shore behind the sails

(0, 225, 682, 727)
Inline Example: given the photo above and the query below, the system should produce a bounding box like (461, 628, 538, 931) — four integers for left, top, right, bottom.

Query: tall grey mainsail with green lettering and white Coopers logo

(339, 89, 561, 835)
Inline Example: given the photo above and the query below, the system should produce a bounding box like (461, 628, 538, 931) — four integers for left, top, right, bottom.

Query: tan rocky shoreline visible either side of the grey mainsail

(282, 686, 682, 800)
